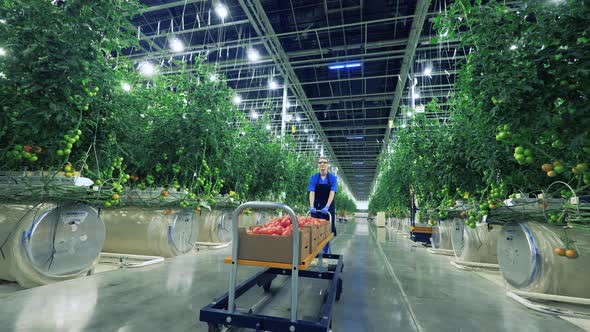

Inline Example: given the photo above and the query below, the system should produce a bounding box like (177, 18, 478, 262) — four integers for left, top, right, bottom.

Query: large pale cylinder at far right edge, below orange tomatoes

(498, 221, 590, 298)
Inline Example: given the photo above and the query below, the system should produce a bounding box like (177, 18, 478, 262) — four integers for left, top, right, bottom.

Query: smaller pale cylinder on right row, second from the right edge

(451, 218, 501, 264)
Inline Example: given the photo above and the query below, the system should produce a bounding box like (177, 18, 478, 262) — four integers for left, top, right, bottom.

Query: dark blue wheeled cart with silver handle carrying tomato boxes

(200, 202, 344, 332)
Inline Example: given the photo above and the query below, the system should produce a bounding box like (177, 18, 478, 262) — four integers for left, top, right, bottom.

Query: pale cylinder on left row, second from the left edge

(102, 207, 199, 257)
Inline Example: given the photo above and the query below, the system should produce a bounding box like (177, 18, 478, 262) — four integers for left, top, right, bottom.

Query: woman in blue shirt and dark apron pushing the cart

(307, 157, 338, 253)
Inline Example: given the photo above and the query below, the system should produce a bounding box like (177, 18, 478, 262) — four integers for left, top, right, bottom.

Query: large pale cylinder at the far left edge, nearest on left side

(0, 202, 105, 288)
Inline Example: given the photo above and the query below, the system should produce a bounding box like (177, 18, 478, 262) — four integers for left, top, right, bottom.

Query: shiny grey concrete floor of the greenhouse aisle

(0, 222, 583, 332)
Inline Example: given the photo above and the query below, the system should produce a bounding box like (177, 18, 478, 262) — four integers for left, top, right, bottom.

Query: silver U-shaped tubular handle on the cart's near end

(227, 202, 299, 322)
